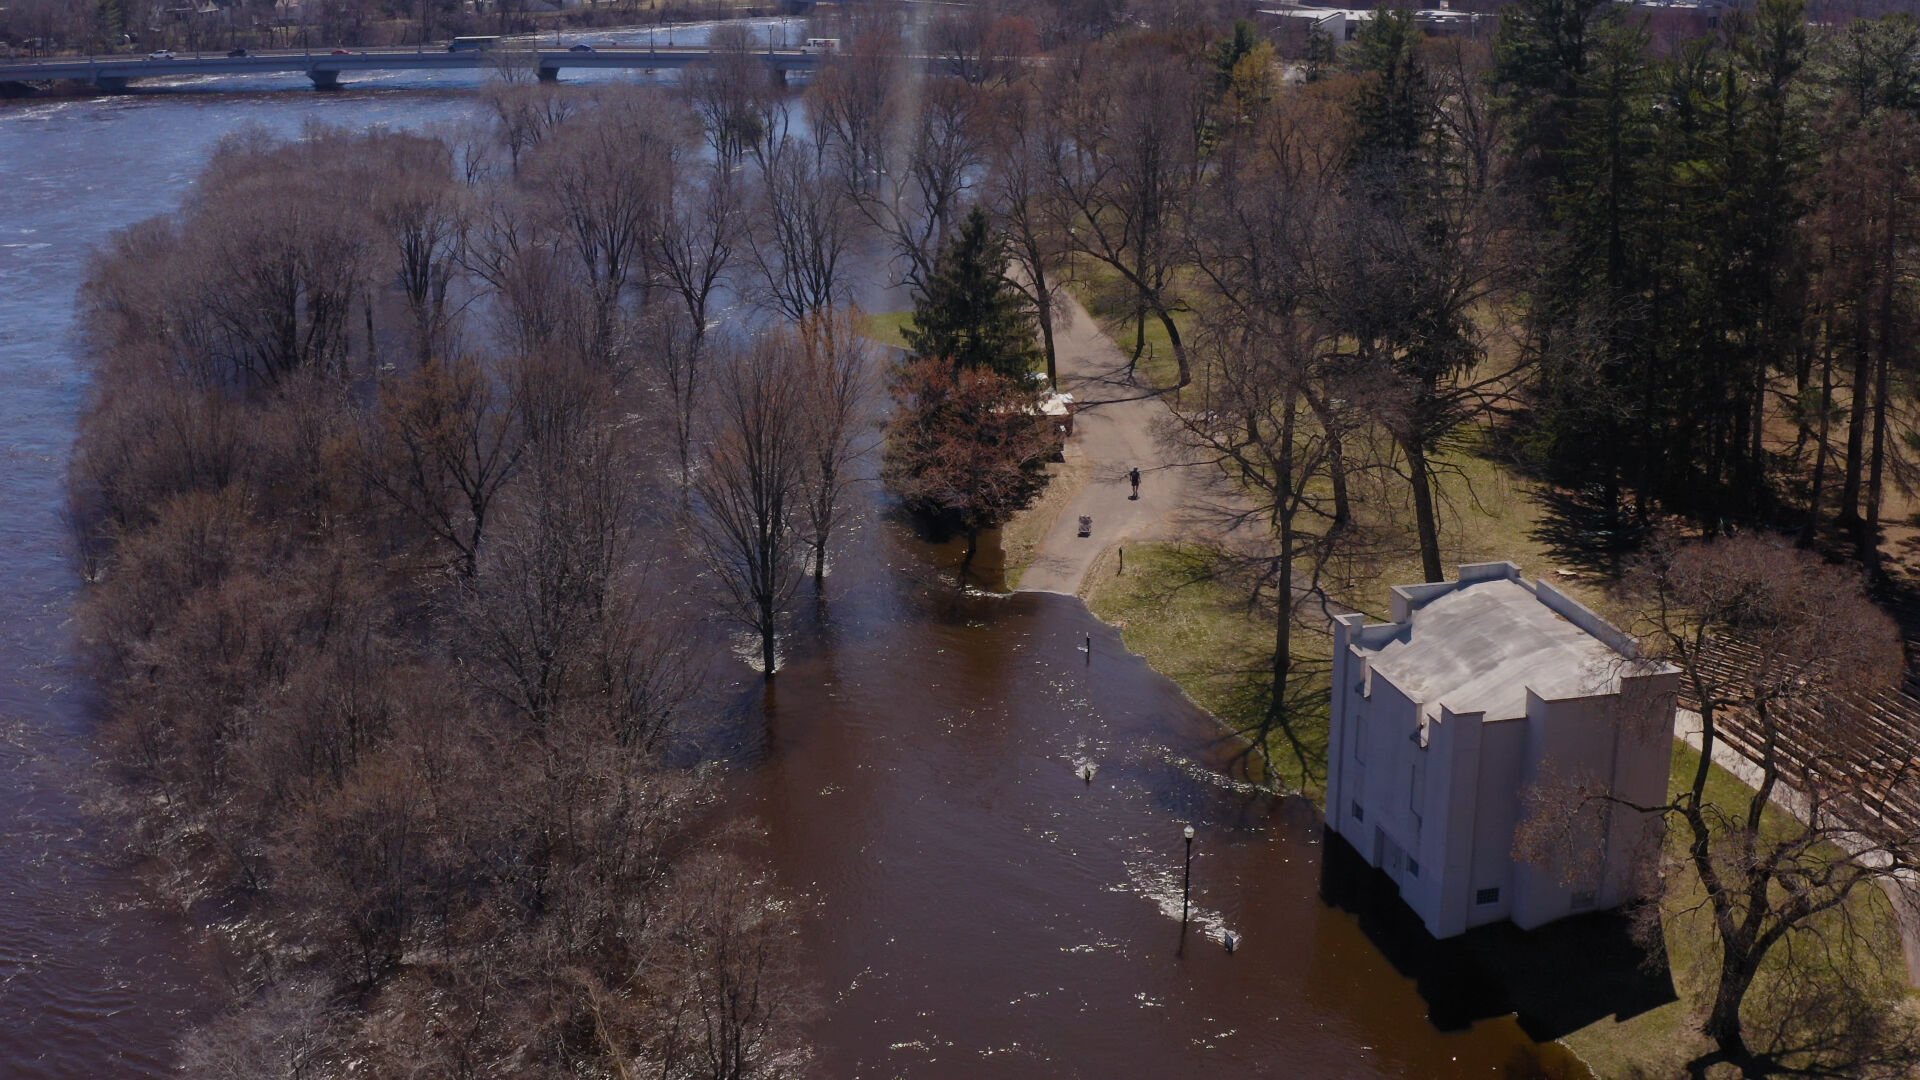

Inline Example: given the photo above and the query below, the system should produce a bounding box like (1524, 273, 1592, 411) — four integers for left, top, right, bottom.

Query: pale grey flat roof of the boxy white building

(1356, 578, 1634, 721)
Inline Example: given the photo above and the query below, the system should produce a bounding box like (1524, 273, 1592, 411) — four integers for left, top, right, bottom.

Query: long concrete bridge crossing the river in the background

(0, 46, 820, 92)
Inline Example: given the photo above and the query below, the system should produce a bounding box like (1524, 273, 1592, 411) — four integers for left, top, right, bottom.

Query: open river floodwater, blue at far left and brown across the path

(0, 61, 1589, 1080)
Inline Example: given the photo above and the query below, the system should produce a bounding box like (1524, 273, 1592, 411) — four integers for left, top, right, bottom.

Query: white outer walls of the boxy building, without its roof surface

(1327, 576, 1678, 938)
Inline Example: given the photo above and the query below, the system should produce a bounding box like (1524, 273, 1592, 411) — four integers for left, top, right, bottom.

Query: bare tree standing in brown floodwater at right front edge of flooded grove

(693, 332, 808, 678)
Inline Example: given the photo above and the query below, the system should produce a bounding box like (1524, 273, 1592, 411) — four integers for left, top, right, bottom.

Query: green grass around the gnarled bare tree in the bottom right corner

(1563, 742, 1905, 1076)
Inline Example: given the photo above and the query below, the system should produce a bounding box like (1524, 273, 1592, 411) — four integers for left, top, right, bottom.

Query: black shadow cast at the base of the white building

(1321, 832, 1678, 1042)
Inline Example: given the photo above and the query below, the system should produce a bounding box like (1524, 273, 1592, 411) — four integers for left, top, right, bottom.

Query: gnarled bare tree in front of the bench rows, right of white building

(1528, 536, 1920, 1074)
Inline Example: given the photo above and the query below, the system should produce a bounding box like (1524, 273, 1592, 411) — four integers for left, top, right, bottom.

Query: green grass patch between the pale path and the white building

(1087, 544, 1332, 794)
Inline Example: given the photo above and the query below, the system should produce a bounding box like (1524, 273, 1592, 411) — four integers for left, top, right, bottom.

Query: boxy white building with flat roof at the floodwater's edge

(1327, 563, 1678, 938)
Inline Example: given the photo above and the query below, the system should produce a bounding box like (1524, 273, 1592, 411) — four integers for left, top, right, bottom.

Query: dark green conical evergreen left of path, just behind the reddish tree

(904, 208, 1041, 379)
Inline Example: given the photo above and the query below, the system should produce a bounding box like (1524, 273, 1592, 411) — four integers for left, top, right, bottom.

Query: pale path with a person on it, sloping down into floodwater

(1020, 296, 1206, 596)
